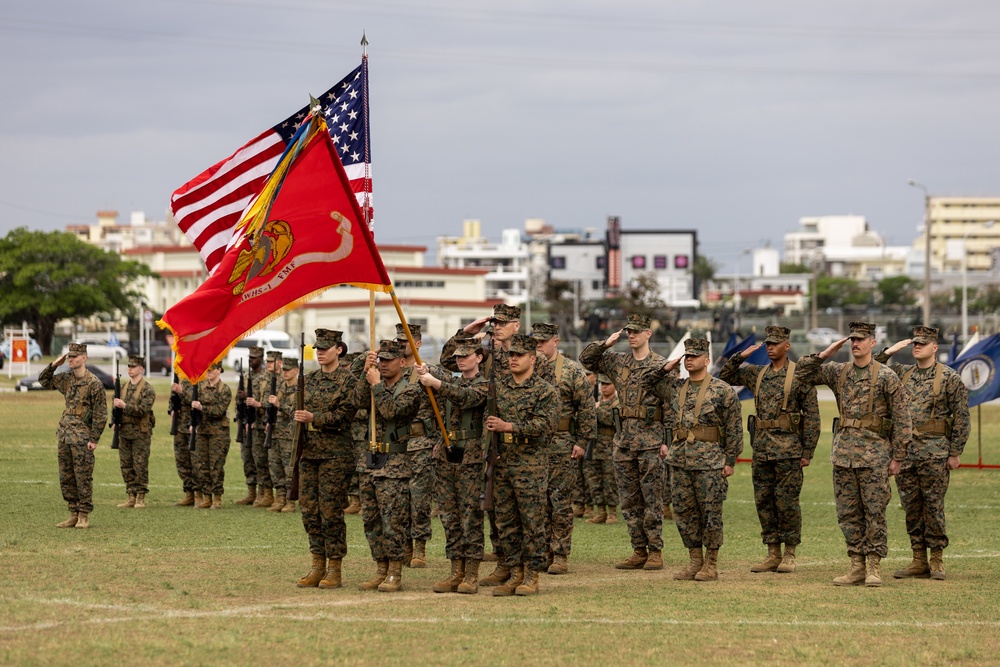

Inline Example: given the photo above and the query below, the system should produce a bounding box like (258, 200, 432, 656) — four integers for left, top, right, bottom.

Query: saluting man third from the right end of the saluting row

(719, 326, 820, 573)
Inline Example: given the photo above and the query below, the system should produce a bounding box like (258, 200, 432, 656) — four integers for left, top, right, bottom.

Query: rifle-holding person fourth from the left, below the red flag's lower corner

(191, 362, 233, 509)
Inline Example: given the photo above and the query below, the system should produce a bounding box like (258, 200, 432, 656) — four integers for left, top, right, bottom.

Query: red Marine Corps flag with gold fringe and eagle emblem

(157, 106, 392, 382)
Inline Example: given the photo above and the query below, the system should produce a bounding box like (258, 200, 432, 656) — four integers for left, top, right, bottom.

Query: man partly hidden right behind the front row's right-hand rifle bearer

(531, 322, 597, 574)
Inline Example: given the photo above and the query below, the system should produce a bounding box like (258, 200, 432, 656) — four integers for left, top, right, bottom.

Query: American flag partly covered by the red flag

(170, 59, 372, 272)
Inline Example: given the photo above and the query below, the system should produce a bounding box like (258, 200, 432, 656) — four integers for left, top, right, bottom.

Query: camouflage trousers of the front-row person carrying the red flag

(434, 461, 485, 560)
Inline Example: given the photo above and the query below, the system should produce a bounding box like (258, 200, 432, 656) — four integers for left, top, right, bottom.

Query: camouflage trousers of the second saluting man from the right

(833, 466, 891, 558)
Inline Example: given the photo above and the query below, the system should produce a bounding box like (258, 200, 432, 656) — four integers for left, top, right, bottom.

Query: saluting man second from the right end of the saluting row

(796, 322, 912, 586)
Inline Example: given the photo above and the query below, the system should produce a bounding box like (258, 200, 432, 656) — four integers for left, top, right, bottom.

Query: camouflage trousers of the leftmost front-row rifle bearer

(298, 456, 354, 558)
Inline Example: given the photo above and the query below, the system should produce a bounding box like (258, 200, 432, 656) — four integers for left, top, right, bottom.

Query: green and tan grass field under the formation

(0, 378, 1000, 666)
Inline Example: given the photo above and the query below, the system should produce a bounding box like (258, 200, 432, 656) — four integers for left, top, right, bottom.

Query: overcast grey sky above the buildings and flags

(0, 0, 1000, 270)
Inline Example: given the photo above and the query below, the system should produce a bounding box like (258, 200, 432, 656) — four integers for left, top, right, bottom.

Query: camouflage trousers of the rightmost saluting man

(896, 459, 951, 549)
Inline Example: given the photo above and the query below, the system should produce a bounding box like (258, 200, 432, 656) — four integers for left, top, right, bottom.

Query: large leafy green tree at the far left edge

(0, 227, 155, 354)
